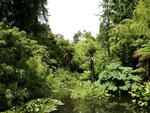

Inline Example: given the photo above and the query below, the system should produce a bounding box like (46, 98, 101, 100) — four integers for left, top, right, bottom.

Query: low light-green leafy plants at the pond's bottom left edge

(3, 98, 63, 113)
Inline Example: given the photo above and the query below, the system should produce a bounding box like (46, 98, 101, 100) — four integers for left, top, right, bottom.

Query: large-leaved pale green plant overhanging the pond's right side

(99, 63, 140, 95)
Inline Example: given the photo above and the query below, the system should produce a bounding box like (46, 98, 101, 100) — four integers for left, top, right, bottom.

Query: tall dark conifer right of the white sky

(97, 0, 138, 56)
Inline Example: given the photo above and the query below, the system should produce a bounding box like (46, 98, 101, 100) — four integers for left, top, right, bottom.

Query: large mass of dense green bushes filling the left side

(0, 23, 50, 111)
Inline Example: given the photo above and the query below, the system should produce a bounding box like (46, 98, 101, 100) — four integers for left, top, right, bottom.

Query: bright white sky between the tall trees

(48, 0, 100, 40)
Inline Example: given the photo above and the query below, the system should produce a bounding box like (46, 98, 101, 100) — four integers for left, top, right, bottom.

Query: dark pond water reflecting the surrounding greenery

(52, 97, 150, 113)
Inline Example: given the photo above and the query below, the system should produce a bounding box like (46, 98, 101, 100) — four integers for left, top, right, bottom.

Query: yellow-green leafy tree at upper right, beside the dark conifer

(109, 0, 150, 68)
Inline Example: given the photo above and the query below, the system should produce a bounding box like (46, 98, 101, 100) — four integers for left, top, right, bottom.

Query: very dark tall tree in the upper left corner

(0, 0, 47, 35)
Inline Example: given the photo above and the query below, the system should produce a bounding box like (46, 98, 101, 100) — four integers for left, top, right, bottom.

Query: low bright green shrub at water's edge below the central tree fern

(71, 81, 108, 100)
